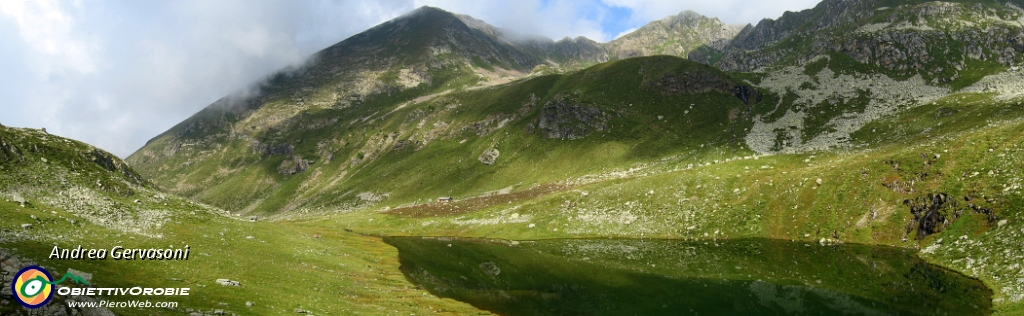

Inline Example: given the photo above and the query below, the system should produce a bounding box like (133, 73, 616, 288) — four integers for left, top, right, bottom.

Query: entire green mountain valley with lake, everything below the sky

(6, 0, 1024, 315)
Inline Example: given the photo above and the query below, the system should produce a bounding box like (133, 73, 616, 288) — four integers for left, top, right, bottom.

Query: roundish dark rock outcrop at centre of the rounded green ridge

(537, 99, 608, 140)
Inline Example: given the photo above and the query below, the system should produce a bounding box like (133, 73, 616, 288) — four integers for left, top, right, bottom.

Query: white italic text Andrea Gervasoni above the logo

(50, 245, 188, 260)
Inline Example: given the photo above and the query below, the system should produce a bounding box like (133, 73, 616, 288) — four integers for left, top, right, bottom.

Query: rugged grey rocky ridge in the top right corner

(708, 0, 1024, 72)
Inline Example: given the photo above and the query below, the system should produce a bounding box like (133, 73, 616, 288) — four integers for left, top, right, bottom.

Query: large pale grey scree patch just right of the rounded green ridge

(745, 56, 949, 153)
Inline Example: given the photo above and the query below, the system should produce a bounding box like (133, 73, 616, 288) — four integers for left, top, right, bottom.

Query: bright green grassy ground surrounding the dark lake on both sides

(0, 94, 1024, 315)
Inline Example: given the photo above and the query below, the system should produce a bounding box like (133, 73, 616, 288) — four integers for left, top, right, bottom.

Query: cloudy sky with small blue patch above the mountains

(0, 0, 815, 156)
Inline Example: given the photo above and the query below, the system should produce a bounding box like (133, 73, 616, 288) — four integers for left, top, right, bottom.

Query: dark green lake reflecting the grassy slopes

(384, 237, 991, 315)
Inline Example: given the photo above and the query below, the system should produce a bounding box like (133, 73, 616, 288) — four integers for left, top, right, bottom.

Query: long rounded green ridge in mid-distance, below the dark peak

(129, 56, 756, 213)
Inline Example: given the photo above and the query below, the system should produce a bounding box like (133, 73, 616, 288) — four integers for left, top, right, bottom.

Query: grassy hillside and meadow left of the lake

(0, 126, 487, 315)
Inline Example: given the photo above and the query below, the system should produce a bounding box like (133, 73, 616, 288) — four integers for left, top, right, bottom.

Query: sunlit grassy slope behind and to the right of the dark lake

(325, 85, 1024, 315)
